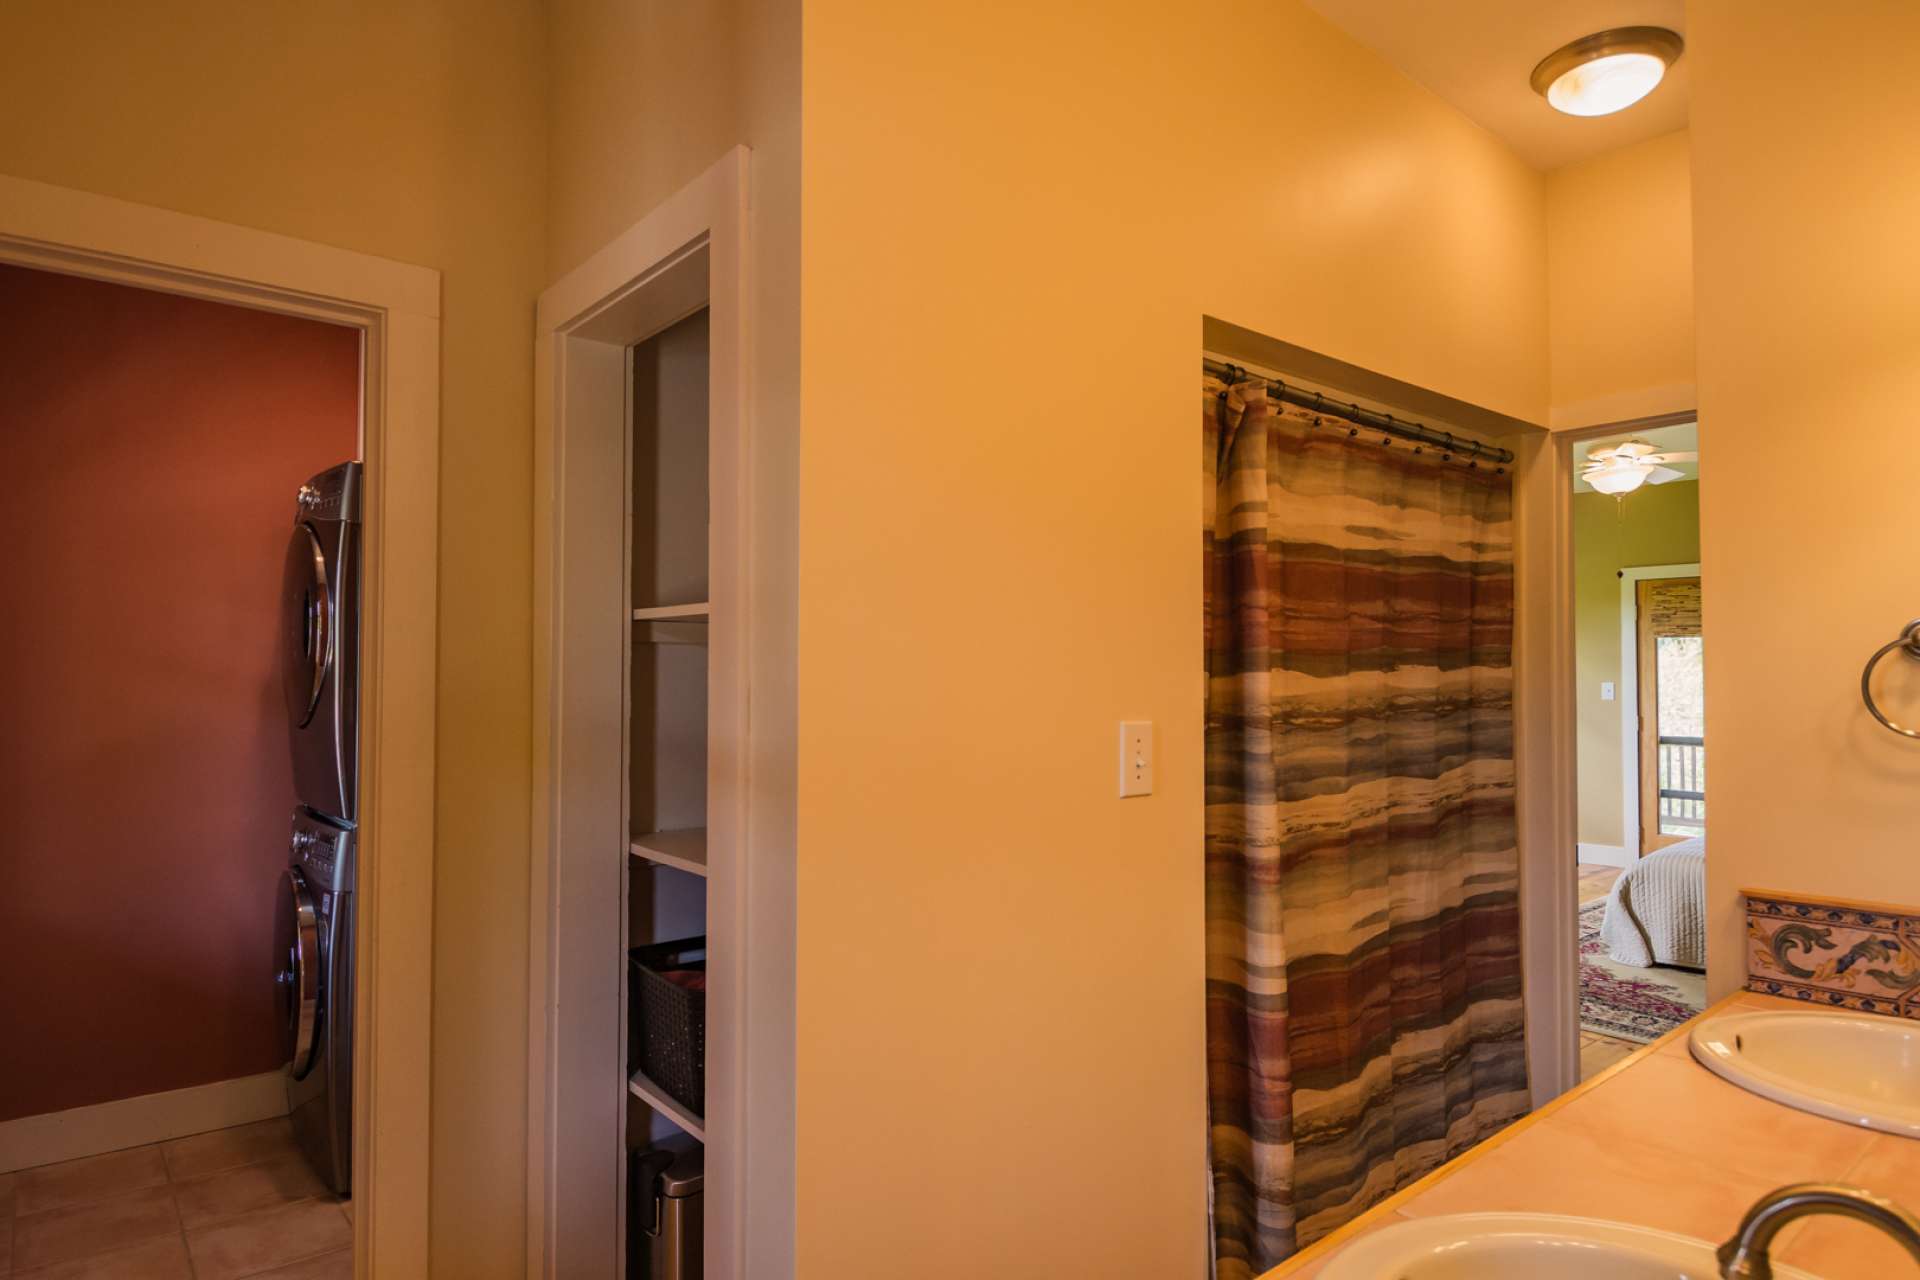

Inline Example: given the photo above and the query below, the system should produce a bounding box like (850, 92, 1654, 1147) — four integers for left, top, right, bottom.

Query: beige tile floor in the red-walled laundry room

(0, 1119, 353, 1280)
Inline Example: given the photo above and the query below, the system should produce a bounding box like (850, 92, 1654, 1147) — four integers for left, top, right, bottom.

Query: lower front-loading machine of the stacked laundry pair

(273, 808, 353, 1196)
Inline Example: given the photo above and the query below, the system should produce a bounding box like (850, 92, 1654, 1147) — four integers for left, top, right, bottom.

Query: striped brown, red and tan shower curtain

(1202, 378, 1528, 1280)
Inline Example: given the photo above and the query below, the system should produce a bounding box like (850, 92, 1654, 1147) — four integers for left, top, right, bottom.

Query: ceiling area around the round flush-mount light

(1306, 0, 1688, 173)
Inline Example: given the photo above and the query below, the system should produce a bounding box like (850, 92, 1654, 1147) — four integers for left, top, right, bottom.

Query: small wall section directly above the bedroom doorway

(1548, 130, 1695, 428)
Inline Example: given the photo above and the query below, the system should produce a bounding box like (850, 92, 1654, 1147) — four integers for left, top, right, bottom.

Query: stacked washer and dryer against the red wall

(275, 462, 361, 1196)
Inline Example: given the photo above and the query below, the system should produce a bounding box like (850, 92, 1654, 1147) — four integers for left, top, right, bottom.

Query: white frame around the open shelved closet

(526, 148, 760, 1280)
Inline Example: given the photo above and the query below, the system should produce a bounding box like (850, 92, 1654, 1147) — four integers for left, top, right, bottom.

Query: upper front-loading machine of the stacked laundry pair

(284, 462, 361, 825)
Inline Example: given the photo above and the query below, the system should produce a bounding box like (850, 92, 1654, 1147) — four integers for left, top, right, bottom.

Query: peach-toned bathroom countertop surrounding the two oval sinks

(1261, 992, 1920, 1280)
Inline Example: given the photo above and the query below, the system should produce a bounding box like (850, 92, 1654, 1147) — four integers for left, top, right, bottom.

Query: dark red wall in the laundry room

(0, 267, 359, 1121)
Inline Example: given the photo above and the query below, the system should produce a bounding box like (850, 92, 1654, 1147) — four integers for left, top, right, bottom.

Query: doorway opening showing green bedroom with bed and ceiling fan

(1563, 422, 1707, 1079)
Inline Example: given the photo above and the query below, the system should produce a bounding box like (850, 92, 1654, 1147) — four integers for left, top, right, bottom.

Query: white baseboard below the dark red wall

(0, 1071, 286, 1173)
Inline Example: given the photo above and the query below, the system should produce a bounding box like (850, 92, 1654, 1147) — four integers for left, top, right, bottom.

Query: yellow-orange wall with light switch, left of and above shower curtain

(797, 0, 1548, 1280)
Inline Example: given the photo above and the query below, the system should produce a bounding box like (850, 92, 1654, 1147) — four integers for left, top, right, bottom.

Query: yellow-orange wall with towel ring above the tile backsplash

(1688, 0, 1920, 990)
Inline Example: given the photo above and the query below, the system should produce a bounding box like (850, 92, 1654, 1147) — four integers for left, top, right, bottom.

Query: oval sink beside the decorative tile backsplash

(1688, 1009, 1920, 1138)
